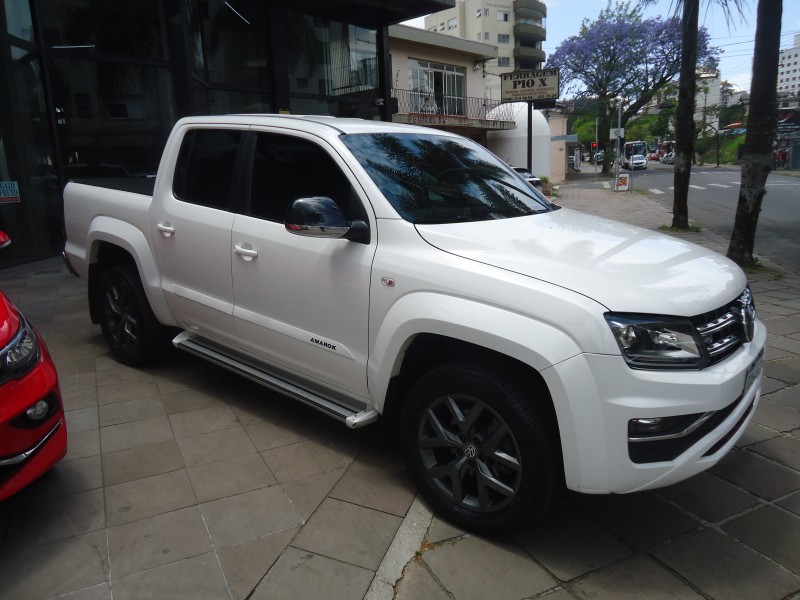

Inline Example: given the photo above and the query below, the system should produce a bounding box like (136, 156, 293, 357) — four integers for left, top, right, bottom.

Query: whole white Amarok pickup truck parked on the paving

(64, 115, 766, 532)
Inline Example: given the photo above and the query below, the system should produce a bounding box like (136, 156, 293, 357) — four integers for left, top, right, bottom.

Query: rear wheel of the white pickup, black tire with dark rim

(99, 267, 167, 366)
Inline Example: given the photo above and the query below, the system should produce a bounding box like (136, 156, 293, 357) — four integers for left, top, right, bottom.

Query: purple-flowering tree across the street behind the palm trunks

(546, 0, 719, 171)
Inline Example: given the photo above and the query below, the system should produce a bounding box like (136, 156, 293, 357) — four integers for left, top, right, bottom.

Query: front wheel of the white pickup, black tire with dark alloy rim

(401, 363, 564, 535)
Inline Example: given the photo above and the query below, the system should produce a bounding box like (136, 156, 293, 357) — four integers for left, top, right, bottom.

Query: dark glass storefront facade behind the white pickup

(0, 0, 440, 269)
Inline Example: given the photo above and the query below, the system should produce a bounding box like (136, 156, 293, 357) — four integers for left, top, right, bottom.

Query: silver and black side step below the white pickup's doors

(172, 331, 380, 429)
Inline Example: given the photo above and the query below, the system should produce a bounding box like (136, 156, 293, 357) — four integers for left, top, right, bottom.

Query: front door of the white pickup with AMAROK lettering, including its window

(232, 128, 376, 398)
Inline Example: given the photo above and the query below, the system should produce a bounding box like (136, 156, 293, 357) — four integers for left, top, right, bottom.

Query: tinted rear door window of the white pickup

(172, 129, 242, 210)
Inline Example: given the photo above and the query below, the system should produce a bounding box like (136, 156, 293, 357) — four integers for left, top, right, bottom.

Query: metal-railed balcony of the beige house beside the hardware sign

(392, 89, 516, 136)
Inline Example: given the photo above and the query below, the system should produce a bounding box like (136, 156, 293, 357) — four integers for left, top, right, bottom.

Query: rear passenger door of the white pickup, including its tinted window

(152, 125, 247, 341)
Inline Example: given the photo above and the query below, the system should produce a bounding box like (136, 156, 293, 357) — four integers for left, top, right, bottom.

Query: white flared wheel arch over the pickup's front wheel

(367, 292, 581, 411)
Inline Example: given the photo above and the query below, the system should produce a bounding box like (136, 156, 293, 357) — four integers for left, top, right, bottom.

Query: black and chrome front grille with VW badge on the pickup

(691, 288, 755, 365)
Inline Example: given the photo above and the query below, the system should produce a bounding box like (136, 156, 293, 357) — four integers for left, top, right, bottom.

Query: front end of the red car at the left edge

(0, 231, 67, 501)
